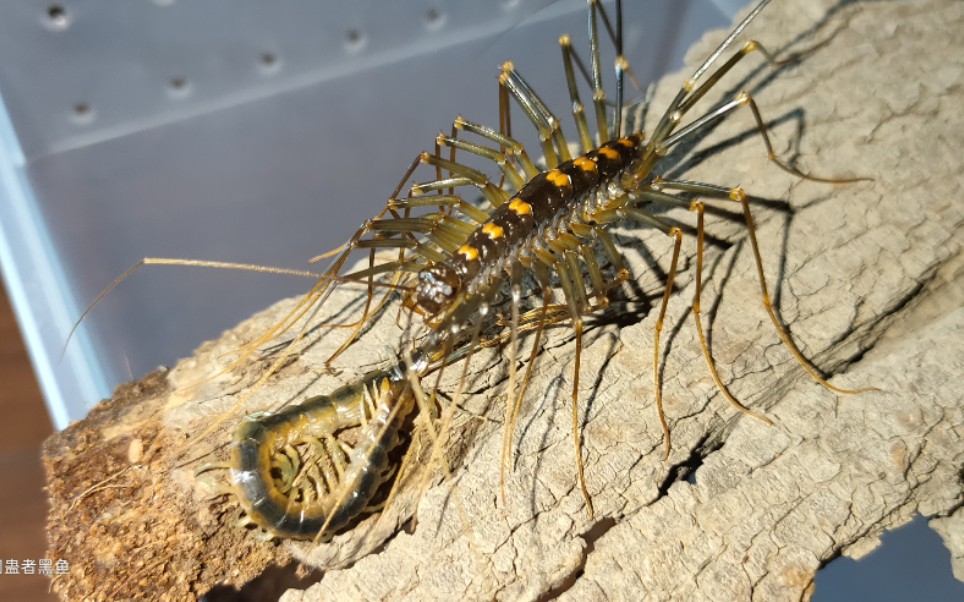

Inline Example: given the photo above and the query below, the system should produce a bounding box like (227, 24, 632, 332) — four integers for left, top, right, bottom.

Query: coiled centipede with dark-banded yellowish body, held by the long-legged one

(231, 358, 414, 539)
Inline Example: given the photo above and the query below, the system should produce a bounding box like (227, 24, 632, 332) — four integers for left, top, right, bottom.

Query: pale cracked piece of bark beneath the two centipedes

(46, 0, 964, 602)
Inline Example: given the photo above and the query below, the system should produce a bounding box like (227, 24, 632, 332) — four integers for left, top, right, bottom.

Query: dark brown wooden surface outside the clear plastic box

(0, 286, 57, 601)
